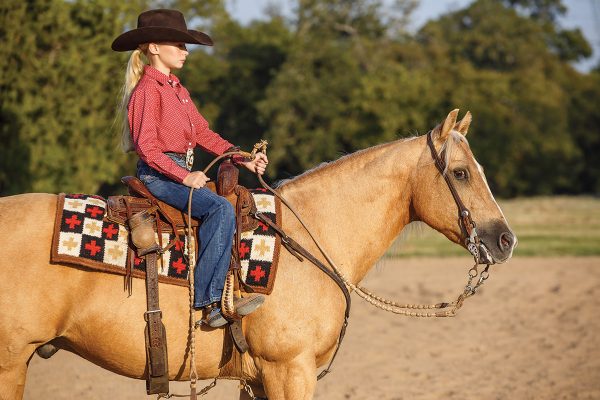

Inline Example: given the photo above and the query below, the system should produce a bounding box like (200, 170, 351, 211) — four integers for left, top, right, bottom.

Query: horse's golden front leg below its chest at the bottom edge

(261, 354, 317, 400)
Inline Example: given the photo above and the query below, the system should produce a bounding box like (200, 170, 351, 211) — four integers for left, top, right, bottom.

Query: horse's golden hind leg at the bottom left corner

(0, 343, 35, 400)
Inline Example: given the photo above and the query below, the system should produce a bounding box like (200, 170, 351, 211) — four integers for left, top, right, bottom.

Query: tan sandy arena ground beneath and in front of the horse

(25, 257, 600, 400)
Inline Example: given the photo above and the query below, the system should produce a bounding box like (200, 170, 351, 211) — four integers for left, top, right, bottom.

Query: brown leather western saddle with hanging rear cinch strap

(112, 159, 258, 394)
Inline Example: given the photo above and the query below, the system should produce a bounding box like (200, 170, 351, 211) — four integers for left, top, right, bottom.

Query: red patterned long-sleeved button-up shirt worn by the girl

(128, 65, 233, 182)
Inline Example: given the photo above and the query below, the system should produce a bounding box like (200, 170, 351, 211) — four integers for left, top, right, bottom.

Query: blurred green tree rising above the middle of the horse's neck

(259, 0, 422, 177)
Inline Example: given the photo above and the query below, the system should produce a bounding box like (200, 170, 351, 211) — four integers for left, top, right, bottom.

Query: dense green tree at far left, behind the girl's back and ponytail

(0, 0, 140, 195)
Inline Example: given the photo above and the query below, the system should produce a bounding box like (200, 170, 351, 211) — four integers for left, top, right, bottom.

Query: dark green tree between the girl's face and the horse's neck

(181, 17, 291, 164)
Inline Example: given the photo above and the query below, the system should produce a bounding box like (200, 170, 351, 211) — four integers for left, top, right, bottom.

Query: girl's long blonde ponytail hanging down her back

(117, 44, 148, 152)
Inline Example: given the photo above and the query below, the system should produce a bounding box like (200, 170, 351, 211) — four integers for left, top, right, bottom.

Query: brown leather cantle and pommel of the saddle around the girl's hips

(107, 160, 258, 233)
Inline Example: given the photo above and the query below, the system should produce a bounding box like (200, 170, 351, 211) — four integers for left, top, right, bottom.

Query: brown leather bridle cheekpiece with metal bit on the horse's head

(427, 131, 492, 265)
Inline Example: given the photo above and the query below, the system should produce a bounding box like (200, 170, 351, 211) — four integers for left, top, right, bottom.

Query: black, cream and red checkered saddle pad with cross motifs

(51, 189, 281, 294)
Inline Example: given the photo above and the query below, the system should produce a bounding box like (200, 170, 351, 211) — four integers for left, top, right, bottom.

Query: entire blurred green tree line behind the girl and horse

(0, 0, 600, 196)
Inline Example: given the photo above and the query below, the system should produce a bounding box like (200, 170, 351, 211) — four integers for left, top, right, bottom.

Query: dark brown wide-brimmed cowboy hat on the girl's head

(111, 9, 213, 51)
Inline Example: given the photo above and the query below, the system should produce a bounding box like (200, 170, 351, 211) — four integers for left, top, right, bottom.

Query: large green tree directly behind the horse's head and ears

(417, 0, 591, 196)
